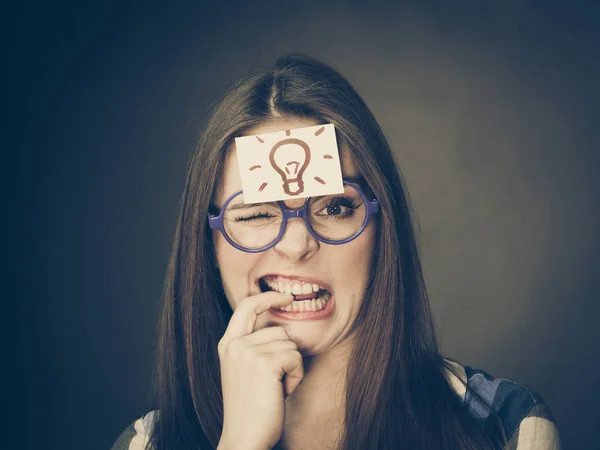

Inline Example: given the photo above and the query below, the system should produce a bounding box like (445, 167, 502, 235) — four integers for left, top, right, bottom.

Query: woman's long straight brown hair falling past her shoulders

(149, 54, 505, 450)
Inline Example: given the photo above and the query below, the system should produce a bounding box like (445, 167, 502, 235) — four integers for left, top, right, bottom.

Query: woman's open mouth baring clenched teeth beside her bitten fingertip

(258, 275, 331, 312)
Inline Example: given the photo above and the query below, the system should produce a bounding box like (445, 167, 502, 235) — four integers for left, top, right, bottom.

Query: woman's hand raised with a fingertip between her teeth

(218, 292, 304, 450)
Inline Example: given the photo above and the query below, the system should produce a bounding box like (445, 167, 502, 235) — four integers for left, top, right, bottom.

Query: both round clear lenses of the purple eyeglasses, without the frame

(223, 185, 366, 249)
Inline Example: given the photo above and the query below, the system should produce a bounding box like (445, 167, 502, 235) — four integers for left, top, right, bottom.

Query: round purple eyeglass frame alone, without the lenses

(208, 180, 379, 253)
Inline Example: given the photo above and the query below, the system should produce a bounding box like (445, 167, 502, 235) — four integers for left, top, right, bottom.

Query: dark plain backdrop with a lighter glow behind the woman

(8, 1, 600, 449)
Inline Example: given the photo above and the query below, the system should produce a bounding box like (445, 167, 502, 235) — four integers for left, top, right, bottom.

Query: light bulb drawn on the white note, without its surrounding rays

(269, 138, 311, 196)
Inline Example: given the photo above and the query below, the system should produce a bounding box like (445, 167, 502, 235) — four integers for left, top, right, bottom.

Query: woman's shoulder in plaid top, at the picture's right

(445, 358, 560, 450)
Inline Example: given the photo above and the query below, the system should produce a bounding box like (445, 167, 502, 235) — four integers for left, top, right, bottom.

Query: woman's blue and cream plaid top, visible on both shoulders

(111, 358, 561, 450)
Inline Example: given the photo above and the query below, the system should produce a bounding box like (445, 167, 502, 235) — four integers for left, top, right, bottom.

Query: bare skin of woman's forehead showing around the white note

(213, 121, 360, 206)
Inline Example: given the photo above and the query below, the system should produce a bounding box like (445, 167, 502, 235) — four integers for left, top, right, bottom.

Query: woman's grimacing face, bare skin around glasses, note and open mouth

(213, 119, 375, 355)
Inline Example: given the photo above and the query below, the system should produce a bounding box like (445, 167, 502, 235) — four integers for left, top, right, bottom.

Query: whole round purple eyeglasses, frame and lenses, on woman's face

(208, 181, 379, 253)
